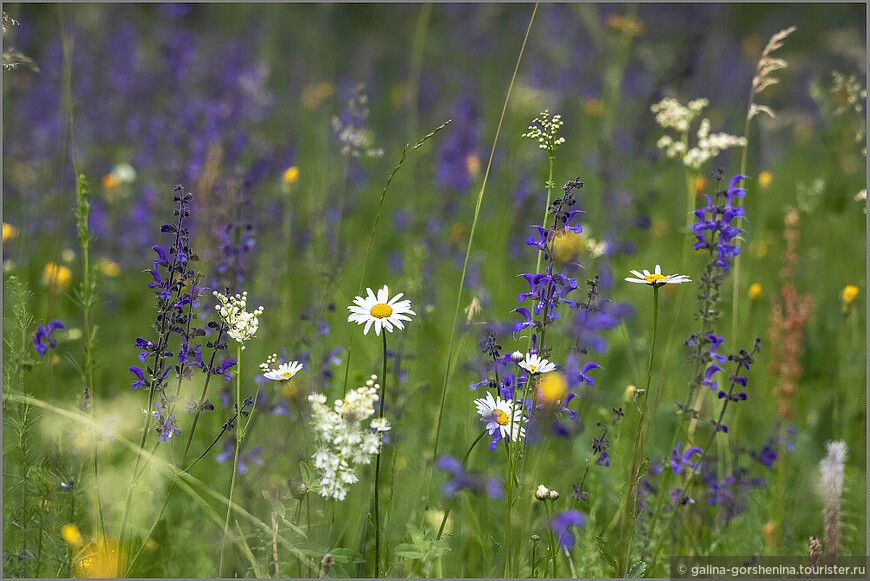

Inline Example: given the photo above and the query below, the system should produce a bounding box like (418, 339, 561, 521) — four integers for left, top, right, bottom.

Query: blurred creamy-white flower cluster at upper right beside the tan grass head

(650, 97, 746, 170)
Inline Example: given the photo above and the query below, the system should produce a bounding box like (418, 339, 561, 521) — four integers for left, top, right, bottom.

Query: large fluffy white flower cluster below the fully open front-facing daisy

(308, 375, 390, 500)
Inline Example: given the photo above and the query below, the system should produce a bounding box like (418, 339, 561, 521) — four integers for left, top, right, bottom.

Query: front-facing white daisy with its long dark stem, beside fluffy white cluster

(347, 285, 417, 577)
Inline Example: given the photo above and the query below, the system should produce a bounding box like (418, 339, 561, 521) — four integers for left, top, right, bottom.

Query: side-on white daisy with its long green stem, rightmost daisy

(617, 264, 691, 576)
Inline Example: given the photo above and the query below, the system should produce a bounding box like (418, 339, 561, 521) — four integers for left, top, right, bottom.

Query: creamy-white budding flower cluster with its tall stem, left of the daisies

(212, 291, 263, 575)
